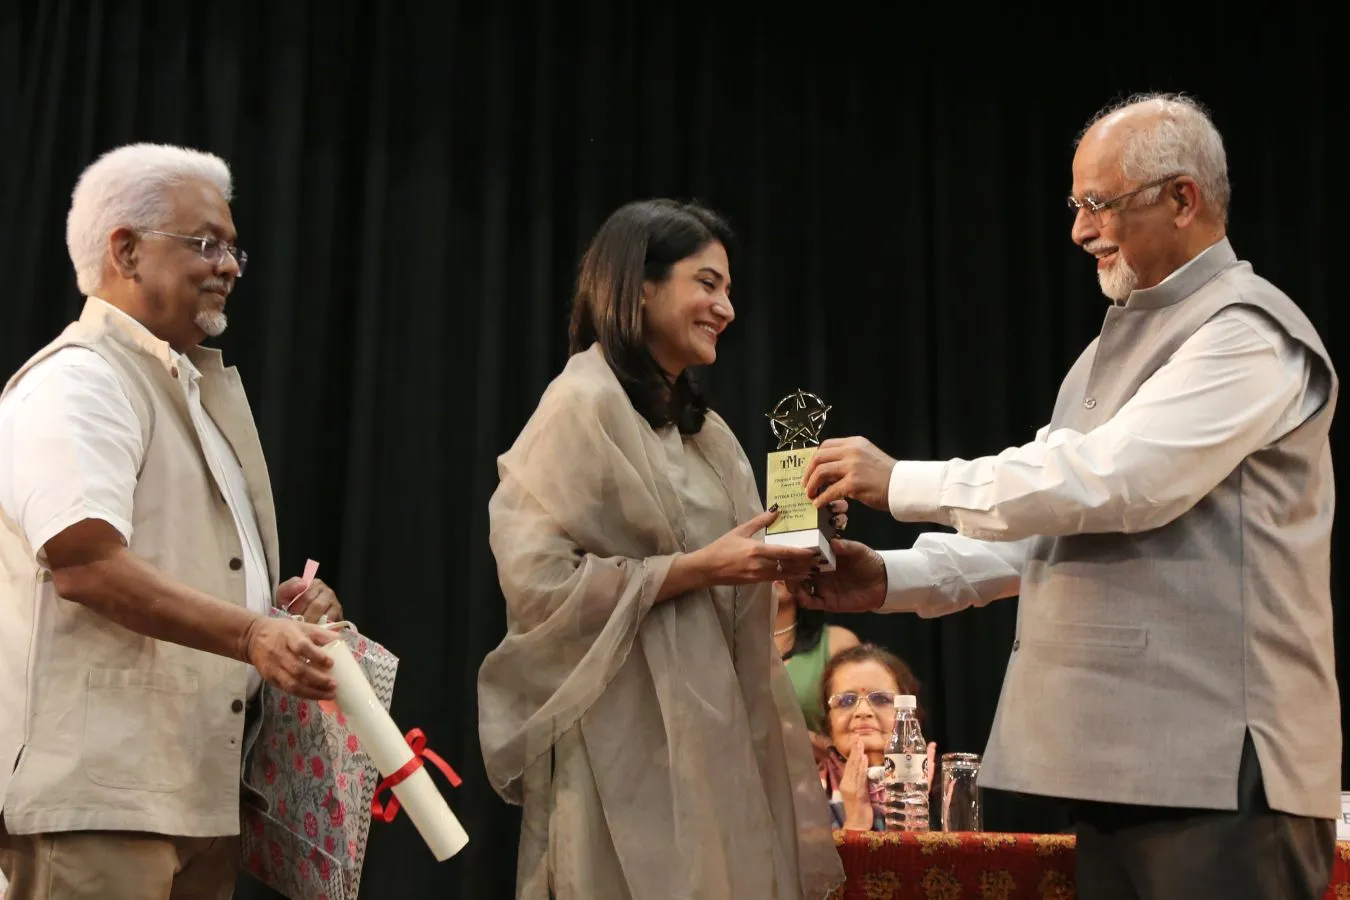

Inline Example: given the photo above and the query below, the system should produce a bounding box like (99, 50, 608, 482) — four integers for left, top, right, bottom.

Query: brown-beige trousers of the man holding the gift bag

(0, 827, 239, 900)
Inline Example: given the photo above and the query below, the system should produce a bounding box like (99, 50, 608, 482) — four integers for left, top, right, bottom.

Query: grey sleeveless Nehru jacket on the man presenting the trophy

(980, 239, 1341, 818)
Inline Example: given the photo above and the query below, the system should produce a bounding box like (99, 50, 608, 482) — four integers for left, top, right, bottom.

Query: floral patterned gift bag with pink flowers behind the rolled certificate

(240, 610, 398, 900)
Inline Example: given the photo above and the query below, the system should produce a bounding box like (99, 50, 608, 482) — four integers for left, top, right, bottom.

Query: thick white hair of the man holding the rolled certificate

(66, 143, 232, 294)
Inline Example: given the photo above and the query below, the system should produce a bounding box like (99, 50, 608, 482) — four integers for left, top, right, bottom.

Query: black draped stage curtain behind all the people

(0, 0, 1350, 899)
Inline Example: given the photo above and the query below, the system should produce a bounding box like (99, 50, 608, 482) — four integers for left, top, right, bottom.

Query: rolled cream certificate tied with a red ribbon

(323, 640, 468, 862)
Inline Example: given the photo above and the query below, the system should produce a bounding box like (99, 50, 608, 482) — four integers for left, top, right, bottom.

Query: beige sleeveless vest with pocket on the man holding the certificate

(0, 300, 278, 837)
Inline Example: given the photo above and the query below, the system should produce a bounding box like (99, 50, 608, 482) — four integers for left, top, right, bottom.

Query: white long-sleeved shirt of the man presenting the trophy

(882, 242, 1330, 617)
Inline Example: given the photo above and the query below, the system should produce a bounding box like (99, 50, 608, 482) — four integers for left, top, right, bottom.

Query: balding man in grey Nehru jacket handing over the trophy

(802, 96, 1342, 900)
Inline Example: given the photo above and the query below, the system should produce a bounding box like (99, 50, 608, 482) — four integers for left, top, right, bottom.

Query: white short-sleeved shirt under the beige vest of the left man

(0, 298, 273, 696)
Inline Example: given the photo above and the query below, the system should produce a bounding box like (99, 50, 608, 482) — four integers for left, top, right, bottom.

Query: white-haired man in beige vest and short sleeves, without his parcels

(0, 144, 342, 900)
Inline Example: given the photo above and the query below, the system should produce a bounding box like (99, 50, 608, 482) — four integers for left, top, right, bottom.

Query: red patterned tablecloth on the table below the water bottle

(830, 831, 1350, 900)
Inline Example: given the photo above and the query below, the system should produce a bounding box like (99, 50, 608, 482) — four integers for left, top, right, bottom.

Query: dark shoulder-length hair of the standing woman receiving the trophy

(567, 200, 736, 434)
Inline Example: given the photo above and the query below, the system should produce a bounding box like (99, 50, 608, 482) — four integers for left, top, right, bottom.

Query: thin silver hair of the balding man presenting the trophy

(1075, 93, 1233, 223)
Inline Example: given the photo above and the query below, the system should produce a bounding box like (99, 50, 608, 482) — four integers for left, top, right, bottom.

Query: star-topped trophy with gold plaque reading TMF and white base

(764, 387, 834, 572)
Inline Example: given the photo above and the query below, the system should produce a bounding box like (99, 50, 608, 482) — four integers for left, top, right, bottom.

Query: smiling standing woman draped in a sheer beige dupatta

(479, 200, 844, 900)
